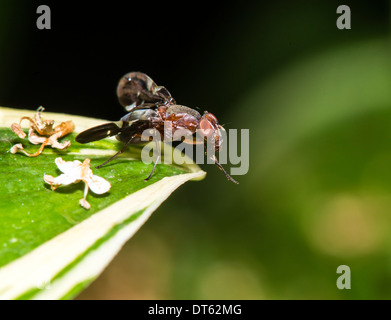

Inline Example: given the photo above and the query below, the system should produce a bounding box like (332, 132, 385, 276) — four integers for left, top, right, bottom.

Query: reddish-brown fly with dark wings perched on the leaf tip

(76, 72, 238, 183)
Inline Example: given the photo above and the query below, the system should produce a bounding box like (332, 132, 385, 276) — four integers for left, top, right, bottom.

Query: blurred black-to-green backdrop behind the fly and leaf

(0, 0, 391, 299)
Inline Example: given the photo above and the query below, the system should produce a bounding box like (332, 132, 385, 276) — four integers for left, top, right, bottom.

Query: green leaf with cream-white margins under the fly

(0, 108, 205, 299)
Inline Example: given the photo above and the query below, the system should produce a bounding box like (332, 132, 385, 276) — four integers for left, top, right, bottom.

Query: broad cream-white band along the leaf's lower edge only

(0, 171, 205, 299)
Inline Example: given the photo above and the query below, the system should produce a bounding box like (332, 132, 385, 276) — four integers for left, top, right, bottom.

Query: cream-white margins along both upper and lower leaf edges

(0, 108, 206, 300)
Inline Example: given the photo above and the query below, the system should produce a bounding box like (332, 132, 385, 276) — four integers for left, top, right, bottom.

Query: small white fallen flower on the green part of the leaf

(43, 158, 111, 210)
